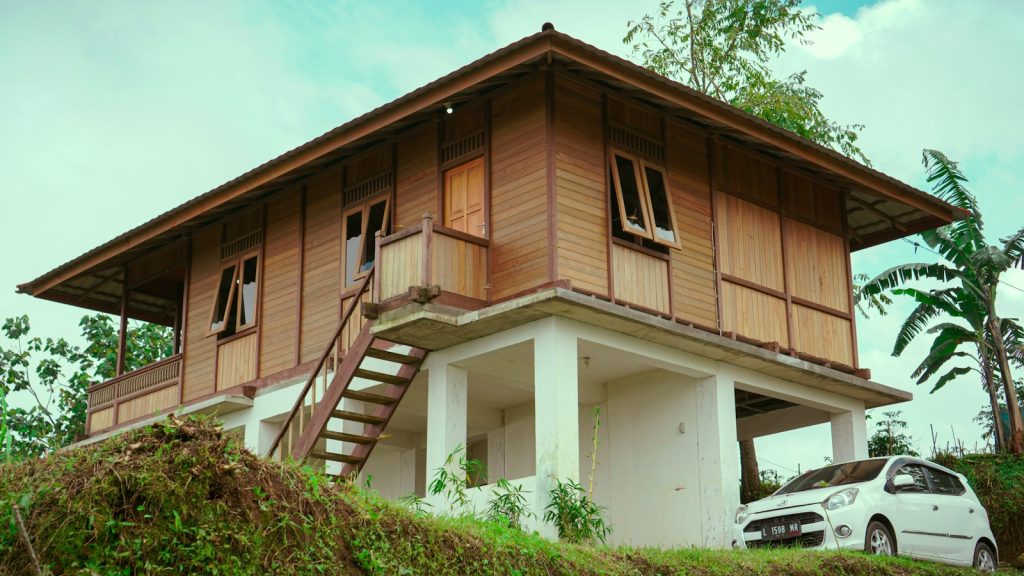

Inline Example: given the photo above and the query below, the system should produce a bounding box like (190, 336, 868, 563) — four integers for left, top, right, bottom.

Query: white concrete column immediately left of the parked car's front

(696, 374, 739, 548)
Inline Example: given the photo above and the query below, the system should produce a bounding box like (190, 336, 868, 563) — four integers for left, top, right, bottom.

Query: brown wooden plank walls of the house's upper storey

(165, 69, 855, 405)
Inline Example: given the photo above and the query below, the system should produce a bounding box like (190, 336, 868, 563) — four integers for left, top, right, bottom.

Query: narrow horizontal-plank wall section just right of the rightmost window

(666, 123, 718, 327)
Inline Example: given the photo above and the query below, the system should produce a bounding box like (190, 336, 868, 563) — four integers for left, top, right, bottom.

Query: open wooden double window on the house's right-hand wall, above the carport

(608, 150, 679, 248)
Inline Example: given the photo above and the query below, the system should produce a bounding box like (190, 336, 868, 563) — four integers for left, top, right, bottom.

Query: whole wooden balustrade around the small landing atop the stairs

(375, 214, 489, 302)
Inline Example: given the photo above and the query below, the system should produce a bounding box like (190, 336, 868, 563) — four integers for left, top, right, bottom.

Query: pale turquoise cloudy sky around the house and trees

(0, 0, 1024, 476)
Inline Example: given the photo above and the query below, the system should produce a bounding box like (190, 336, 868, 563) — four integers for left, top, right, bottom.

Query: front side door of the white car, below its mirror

(889, 463, 945, 559)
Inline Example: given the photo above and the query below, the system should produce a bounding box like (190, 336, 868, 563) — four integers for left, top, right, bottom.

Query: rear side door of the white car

(925, 466, 981, 564)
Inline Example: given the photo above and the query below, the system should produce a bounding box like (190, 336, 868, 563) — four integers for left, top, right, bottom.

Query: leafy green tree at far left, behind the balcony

(0, 314, 173, 460)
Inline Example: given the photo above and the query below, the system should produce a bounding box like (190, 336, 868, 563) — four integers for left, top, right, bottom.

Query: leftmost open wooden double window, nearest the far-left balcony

(210, 252, 259, 336)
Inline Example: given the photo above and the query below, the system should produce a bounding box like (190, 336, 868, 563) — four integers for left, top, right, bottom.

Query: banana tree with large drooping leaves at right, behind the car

(861, 150, 1024, 455)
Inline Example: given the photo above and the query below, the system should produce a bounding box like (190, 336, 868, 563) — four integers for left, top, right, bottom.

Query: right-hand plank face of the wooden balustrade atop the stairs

(430, 232, 487, 300)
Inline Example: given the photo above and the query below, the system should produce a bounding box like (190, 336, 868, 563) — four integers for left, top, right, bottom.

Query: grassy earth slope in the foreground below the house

(0, 420, 983, 576)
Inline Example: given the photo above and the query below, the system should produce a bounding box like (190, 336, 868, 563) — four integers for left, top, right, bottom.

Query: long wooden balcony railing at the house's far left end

(85, 354, 181, 434)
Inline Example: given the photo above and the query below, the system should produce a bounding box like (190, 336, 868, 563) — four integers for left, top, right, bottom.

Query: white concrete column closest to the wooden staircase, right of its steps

(426, 358, 469, 513)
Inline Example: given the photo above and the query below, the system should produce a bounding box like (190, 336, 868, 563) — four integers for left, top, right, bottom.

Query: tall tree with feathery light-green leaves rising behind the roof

(623, 0, 869, 164)
